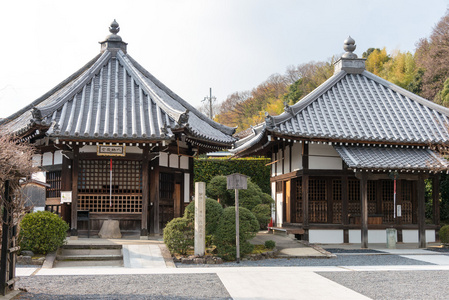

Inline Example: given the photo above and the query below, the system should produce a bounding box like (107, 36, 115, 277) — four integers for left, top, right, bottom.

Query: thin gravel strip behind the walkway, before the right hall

(176, 254, 433, 268)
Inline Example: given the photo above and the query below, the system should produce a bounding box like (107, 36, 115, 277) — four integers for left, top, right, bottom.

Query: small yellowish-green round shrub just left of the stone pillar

(164, 218, 194, 255)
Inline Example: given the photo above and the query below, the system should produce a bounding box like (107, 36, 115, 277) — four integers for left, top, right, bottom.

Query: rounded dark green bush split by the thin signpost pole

(214, 206, 259, 260)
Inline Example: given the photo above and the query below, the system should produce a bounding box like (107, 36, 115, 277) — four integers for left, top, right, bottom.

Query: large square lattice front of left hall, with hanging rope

(78, 159, 142, 213)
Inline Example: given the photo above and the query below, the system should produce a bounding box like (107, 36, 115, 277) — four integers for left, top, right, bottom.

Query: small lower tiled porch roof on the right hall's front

(334, 146, 449, 171)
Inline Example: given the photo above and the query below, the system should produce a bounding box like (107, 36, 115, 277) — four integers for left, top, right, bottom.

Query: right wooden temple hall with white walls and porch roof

(232, 37, 449, 247)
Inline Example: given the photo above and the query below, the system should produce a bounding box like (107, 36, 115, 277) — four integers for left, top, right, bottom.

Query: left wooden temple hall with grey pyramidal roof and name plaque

(0, 20, 235, 237)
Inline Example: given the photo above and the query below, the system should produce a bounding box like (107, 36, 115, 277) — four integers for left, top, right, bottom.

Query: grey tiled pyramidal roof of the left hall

(0, 22, 235, 146)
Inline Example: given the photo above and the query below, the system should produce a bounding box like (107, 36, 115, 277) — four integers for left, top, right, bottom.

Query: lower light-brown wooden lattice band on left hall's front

(78, 194, 142, 213)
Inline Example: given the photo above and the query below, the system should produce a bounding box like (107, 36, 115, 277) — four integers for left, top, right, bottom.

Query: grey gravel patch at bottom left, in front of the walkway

(13, 274, 232, 300)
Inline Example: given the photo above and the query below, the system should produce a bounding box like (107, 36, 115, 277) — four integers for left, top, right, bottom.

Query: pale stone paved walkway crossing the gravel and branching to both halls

(8, 234, 449, 299)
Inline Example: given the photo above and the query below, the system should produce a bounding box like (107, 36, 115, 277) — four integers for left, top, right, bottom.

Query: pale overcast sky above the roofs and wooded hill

(0, 0, 449, 117)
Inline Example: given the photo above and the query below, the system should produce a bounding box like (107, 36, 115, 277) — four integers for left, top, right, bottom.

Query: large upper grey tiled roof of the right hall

(267, 70, 449, 144)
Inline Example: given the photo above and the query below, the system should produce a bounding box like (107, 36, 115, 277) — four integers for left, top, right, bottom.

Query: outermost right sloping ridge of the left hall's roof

(126, 54, 237, 135)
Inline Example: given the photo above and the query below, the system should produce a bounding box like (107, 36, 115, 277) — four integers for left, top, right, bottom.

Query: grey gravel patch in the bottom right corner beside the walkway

(317, 271, 449, 300)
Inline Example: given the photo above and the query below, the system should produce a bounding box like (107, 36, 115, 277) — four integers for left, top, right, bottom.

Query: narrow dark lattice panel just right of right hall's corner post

(309, 179, 327, 223)
